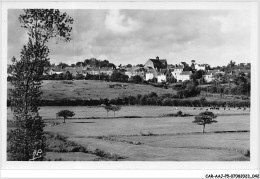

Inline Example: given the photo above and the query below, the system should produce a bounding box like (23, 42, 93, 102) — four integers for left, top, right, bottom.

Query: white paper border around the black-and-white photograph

(0, 1, 260, 178)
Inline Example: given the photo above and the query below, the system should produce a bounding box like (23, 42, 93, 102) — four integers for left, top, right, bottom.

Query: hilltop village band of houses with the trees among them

(13, 56, 250, 83)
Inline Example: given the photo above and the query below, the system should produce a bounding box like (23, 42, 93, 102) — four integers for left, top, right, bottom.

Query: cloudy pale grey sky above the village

(8, 9, 251, 66)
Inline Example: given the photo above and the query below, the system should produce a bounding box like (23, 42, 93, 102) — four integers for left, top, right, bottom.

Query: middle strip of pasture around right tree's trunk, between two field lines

(46, 116, 250, 137)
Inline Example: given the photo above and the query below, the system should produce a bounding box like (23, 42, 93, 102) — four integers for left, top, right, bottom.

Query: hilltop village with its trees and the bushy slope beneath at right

(7, 56, 251, 97)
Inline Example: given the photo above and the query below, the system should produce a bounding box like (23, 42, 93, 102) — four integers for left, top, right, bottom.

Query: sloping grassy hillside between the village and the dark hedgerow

(7, 80, 176, 100)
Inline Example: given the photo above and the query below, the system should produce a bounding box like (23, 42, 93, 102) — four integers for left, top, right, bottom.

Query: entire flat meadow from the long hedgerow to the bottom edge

(8, 106, 250, 161)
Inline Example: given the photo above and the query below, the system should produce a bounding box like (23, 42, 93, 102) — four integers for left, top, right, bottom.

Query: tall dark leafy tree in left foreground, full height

(9, 9, 73, 161)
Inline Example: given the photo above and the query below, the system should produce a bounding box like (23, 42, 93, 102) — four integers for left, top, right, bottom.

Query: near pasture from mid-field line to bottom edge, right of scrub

(45, 115, 250, 161)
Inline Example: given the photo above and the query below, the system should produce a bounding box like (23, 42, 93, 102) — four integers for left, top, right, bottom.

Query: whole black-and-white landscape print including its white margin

(1, 2, 259, 178)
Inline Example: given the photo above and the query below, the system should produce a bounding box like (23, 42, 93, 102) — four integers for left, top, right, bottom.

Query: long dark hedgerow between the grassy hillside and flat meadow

(7, 94, 250, 107)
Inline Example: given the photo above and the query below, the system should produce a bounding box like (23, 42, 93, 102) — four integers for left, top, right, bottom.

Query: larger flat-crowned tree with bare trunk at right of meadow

(192, 111, 218, 133)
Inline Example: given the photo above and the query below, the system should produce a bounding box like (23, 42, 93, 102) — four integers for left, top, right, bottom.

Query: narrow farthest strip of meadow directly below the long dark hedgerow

(7, 106, 250, 120)
